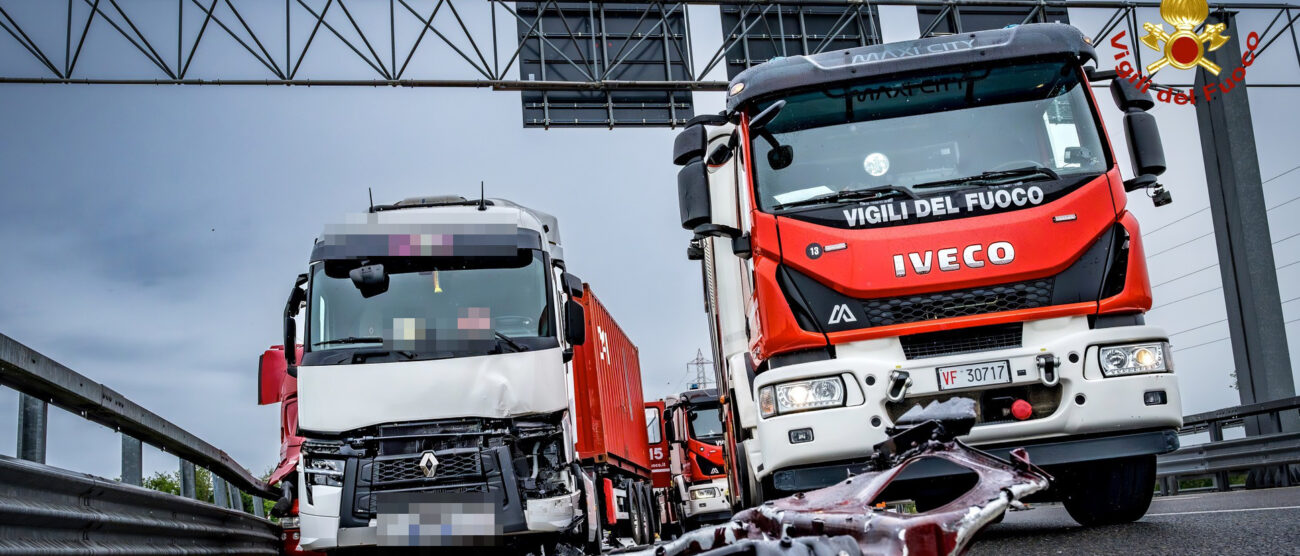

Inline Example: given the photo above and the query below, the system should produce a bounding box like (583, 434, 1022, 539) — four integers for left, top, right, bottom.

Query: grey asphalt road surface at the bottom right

(967, 487, 1300, 556)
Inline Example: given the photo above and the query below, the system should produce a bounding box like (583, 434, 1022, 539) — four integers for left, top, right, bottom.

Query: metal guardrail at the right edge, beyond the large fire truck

(1156, 396, 1300, 494)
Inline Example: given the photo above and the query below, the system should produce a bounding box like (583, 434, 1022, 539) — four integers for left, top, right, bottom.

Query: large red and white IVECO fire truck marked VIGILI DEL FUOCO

(675, 23, 1182, 524)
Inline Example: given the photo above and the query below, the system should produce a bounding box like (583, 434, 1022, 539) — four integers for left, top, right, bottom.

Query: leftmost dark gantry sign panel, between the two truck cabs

(516, 1, 694, 127)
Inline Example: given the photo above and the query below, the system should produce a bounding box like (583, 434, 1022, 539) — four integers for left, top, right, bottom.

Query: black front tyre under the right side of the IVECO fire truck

(1062, 456, 1156, 526)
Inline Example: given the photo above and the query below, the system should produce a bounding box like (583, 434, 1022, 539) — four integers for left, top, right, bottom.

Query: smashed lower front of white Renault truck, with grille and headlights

(299, 416, 579, 550)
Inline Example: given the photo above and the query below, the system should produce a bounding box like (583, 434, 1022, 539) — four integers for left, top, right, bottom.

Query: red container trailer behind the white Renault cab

(573, 283, 658, 544)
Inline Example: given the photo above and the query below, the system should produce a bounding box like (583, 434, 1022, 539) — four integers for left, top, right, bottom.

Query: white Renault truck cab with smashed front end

(285, 196, 595, 552)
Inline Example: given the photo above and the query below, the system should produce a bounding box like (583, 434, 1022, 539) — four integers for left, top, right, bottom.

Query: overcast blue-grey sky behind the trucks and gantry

(0, 3, 1300, 477)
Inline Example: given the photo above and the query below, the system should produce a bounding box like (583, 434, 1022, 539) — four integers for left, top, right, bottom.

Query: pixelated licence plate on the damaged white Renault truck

(374, 492, 504, 547)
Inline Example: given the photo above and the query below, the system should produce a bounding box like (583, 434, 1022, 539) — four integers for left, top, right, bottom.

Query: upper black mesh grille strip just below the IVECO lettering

(862, 278, 1054, 326)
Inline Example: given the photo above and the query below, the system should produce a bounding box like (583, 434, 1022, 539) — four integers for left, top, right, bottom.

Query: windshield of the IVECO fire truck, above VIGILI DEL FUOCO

(750, 61, 1109, 212)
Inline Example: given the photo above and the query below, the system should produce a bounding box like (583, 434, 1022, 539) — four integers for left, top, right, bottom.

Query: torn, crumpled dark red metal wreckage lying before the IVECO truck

(629, 398, 1050, 556)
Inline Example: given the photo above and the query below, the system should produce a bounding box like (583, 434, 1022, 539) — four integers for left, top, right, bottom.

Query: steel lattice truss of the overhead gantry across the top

(0, 0, 1300, 125)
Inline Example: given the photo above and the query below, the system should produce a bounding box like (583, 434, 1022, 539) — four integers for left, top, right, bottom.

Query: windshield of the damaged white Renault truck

(303, 249, 559, 365)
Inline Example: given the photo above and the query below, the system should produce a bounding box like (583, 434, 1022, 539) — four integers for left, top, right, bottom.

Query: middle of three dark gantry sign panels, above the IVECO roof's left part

(722, 4, 880, 79)
